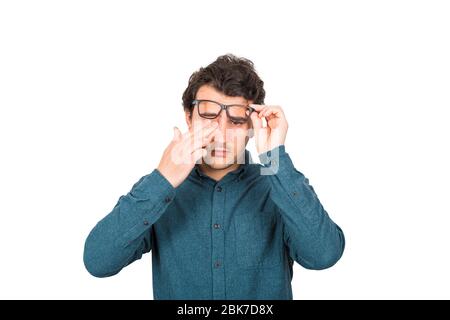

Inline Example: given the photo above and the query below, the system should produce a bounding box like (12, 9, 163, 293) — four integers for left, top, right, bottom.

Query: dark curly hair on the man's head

(183, 54, 266, 116)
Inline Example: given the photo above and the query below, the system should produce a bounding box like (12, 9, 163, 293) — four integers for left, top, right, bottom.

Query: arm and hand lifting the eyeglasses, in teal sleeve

(251, 104, 345, 269)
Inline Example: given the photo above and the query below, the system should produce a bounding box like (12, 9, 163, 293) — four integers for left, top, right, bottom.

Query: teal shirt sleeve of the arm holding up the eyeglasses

(259, 145, 345, 270)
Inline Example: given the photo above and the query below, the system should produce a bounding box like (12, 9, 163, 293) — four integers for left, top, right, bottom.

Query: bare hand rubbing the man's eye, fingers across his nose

(157, 121, 218, 188)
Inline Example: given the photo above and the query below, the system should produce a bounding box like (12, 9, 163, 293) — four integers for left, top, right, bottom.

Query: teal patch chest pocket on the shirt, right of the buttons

(234, 211, 282, 268)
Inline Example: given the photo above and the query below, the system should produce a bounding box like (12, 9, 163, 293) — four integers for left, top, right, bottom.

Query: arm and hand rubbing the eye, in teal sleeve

(84, 121, 217, 277)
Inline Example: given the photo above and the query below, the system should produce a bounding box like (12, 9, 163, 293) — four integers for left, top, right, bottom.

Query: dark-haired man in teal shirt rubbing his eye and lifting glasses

(84, 55, 344, 299)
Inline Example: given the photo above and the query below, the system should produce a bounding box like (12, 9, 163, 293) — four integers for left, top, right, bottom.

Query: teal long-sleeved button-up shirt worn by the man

(84, 145, 345, 299)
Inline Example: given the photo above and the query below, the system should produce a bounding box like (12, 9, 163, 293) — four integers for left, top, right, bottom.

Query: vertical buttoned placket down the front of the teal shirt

(212, 186, 226, 299)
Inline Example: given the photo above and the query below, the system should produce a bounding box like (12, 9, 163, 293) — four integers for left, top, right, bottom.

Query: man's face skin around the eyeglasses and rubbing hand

(186, 85, 252, 170)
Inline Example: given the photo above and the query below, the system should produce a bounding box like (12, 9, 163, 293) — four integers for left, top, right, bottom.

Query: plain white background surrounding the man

(0, 0, 450, 299)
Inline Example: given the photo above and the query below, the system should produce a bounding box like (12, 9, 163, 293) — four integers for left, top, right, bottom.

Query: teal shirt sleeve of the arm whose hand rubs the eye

(83, 169, 175, 277)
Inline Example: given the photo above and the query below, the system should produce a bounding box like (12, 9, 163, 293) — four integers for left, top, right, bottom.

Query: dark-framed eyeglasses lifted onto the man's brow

(192, 100, 255, 124)
